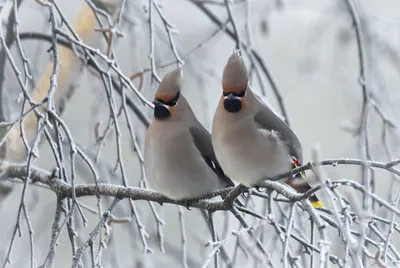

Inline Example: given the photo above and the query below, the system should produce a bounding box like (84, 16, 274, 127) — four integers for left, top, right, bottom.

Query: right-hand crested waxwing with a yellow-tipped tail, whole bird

(212, 50, 322, 208)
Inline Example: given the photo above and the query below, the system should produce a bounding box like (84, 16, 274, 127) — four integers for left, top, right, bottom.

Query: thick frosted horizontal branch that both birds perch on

(0, 158, 400, 216)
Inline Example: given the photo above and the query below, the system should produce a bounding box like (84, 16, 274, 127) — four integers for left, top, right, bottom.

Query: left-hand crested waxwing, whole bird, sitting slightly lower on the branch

(144, 68, 234, 200)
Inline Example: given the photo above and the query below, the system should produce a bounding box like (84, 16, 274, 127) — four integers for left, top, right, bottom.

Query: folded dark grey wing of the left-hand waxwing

(190, 123, 235, 186)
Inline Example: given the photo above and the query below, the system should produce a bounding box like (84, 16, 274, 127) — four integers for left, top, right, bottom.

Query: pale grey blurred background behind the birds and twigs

(0, 0, 400, 267)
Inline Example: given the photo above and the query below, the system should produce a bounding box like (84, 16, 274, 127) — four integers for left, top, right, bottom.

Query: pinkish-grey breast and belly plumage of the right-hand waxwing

(212, 88, 301, 186)
